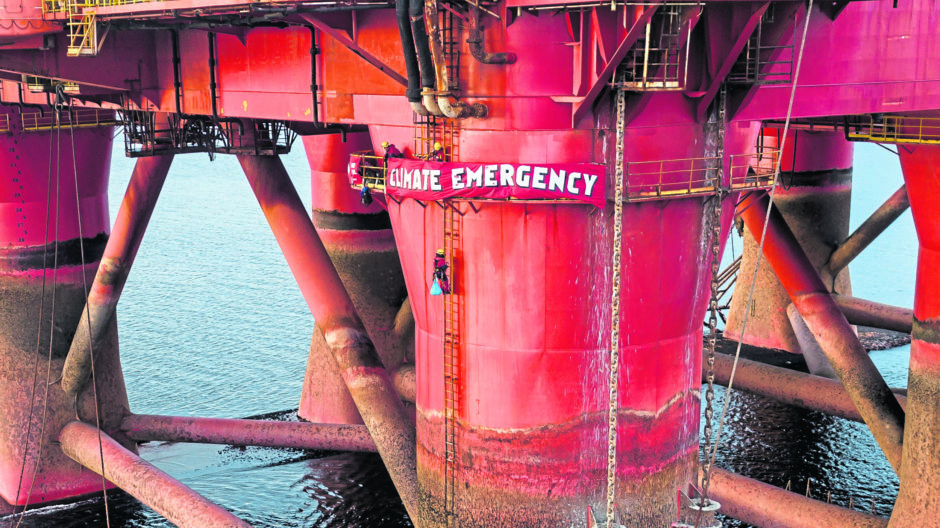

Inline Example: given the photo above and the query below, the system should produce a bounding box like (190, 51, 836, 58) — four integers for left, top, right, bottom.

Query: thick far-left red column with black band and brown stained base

(0, 107, 128, 505)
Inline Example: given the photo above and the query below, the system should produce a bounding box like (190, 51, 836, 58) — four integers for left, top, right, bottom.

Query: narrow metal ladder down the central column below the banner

(444, 200, 463, 528)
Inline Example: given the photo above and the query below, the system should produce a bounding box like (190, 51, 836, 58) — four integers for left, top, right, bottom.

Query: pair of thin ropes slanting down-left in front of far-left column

(10, 100, 59, 527)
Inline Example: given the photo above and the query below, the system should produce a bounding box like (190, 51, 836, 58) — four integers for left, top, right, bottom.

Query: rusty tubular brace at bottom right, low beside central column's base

(709, 469, 892, 528)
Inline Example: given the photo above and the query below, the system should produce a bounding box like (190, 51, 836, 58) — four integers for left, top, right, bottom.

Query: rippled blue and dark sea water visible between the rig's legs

(0, 138, 917, 528)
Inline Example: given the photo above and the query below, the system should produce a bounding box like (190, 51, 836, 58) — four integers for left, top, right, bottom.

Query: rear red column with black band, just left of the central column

(298, 132, 407, 423)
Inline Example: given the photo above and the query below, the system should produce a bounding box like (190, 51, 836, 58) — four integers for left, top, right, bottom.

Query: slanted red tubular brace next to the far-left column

(62, 155, 173, 398)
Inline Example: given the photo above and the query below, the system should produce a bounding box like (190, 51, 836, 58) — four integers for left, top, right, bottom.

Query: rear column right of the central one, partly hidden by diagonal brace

(724, 129, 853, 352)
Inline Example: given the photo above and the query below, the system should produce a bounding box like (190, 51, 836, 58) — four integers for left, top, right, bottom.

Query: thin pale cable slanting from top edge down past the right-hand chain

(703, 0, 813, 510)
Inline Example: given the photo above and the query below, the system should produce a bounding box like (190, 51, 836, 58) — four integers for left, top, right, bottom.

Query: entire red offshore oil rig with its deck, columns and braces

(0, 0, 940, 528)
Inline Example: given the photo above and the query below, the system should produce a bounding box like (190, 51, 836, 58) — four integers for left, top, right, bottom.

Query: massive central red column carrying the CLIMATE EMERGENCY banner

(386, 106, 756, 527)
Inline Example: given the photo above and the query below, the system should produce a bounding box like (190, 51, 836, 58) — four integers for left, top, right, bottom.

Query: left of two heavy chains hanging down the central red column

(607, 67, 626, 528)
